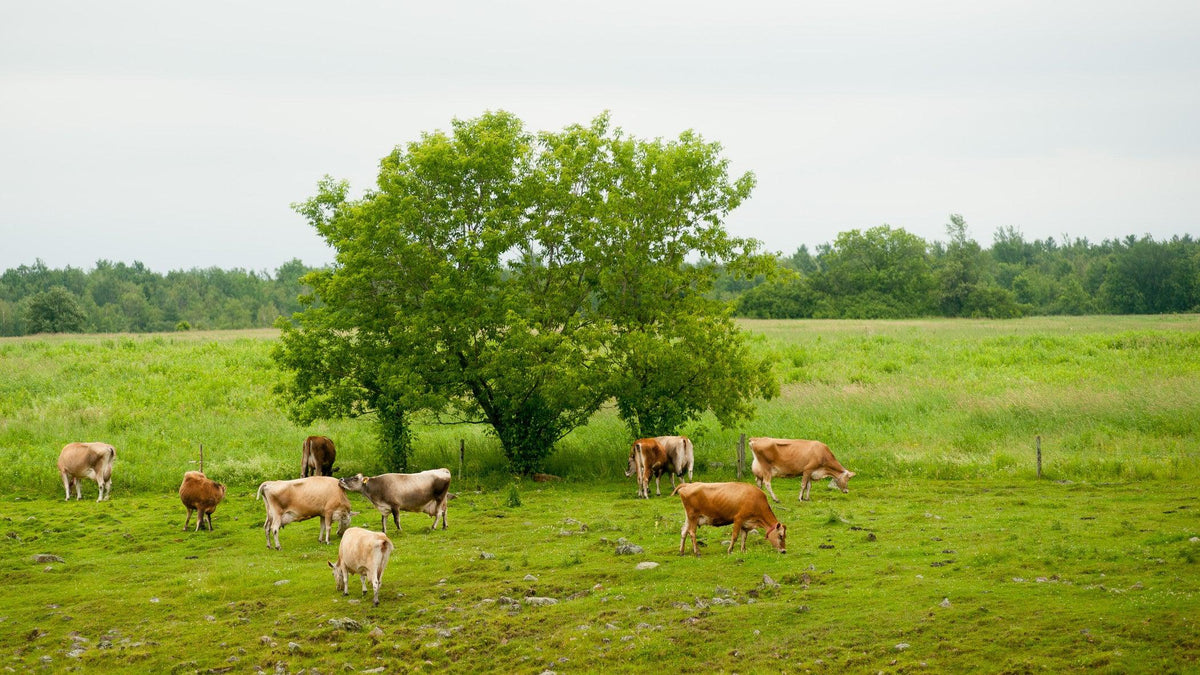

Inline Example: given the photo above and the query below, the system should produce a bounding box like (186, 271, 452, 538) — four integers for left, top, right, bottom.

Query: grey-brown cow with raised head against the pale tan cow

(337, 468, 450, 533)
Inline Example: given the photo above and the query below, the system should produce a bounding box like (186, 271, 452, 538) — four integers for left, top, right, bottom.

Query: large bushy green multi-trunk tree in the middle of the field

(276, 112, 776, 472)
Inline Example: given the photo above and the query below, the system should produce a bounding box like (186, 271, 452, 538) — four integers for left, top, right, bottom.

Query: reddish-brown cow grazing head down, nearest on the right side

(671, 483, 787, 556)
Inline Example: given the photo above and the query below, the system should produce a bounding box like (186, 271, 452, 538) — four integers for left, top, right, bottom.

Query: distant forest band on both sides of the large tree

(0, 215, 1200, 335)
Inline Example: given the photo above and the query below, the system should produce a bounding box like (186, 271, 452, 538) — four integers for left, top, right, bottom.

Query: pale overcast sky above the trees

(0, 0, 1200, 271)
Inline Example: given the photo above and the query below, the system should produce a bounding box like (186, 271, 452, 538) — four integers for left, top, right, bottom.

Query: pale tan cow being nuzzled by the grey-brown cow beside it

(254, 476, 355, 550)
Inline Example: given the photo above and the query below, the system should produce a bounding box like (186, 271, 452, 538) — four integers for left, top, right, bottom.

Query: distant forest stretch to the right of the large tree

(720, 214, 1200, 318)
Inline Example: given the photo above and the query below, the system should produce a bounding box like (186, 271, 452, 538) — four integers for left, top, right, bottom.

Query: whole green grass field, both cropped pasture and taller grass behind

(0, 316, 1200, 673)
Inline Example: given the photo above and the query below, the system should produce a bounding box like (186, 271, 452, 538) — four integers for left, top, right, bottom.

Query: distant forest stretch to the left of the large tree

(0, 259, 311, 335)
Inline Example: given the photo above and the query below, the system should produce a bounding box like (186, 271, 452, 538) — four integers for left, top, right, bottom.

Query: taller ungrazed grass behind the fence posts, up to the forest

(0, 316, 1200, 494)
